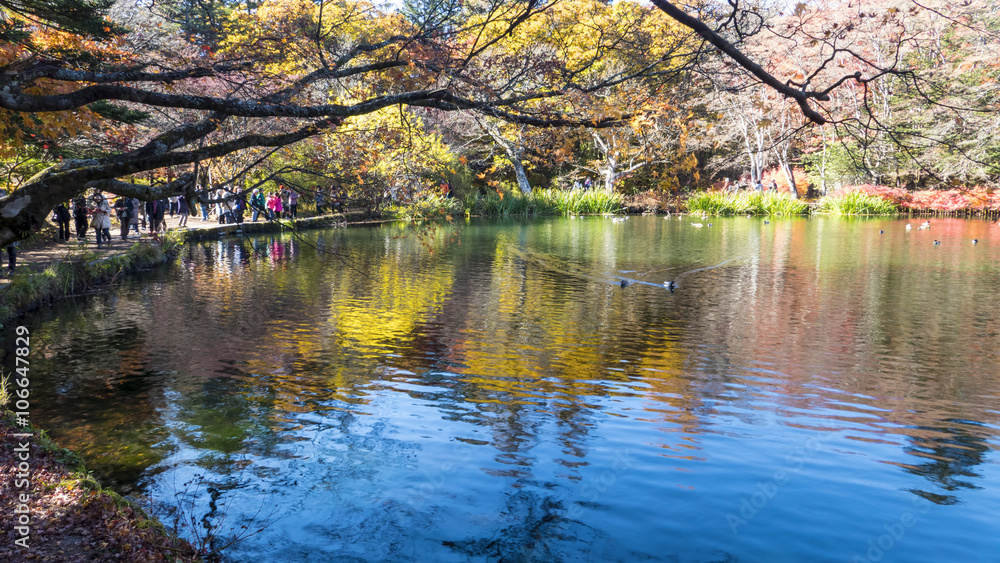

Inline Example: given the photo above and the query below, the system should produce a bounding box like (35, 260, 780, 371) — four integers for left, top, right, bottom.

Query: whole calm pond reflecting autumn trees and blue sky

(4, 217, 1000, 562)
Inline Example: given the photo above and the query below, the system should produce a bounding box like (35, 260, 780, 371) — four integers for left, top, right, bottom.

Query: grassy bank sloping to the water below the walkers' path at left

(0, 234, 182, 323)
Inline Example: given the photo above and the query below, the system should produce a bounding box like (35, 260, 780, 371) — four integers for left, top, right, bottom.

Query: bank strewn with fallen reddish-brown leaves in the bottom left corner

(0, 410, 202, 563)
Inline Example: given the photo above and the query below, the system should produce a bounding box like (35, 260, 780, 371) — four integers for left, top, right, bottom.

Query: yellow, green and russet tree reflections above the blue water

(17, 219, 1000, 506)
